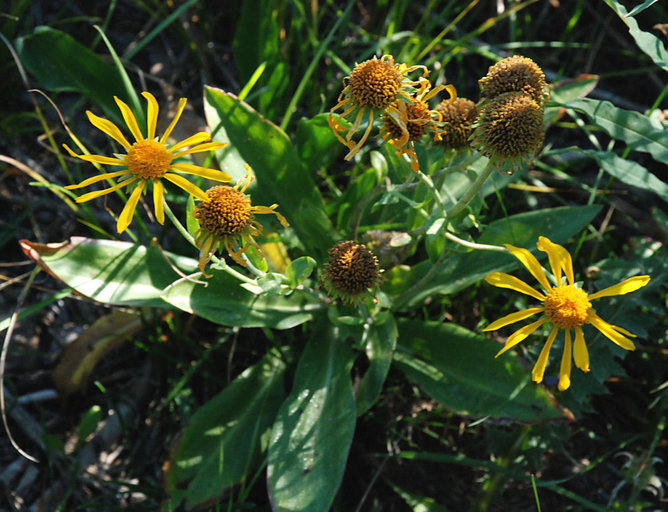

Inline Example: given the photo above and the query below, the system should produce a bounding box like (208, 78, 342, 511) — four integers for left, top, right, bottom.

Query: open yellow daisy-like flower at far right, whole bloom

(483, 236, 650, 391)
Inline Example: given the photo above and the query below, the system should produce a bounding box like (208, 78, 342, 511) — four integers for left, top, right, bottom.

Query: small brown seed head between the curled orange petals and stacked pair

(434, 98, 478, 149)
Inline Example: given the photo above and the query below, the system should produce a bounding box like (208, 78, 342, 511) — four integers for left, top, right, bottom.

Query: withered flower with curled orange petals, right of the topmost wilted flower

(380, 78, 457, 171)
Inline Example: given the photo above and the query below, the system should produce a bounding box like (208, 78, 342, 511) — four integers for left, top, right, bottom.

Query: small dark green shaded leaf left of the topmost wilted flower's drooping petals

(297, 114, 346, 172)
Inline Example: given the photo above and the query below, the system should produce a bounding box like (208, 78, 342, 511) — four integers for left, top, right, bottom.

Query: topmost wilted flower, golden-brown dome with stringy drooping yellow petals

(328, 55, 429, 160)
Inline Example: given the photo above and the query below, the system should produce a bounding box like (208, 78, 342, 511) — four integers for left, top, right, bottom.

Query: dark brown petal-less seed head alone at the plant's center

(323, 240, 382, 303)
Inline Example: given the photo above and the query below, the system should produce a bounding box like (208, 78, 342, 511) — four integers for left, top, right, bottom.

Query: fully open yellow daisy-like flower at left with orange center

(63, 92, 232, 233)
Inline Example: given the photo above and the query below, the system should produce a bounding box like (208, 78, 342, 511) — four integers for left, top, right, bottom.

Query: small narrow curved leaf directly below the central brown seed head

(356, 311, 398, 416)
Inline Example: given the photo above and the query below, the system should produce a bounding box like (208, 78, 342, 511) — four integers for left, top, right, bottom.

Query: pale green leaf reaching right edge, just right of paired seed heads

(564, 98, 668, 164)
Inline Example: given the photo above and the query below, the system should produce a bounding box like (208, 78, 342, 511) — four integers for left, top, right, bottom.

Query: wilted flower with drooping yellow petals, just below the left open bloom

(193, 164, 288, 273)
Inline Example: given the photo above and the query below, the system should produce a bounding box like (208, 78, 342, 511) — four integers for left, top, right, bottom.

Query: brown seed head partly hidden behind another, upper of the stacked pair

(478, 55, 550, 106)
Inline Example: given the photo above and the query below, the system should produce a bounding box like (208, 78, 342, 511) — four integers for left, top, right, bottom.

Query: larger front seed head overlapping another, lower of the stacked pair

(472, 92, 545, 172)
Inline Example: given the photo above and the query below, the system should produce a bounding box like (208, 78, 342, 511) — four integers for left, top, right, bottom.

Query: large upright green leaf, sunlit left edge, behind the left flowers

(205, 87, 334, 256)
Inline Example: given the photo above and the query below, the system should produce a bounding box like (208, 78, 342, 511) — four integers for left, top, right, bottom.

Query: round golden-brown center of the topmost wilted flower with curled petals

(348, 57, 402, 109)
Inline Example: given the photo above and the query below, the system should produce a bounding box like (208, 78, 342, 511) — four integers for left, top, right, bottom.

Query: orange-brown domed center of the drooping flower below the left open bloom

(193, 185, 253, 237)
